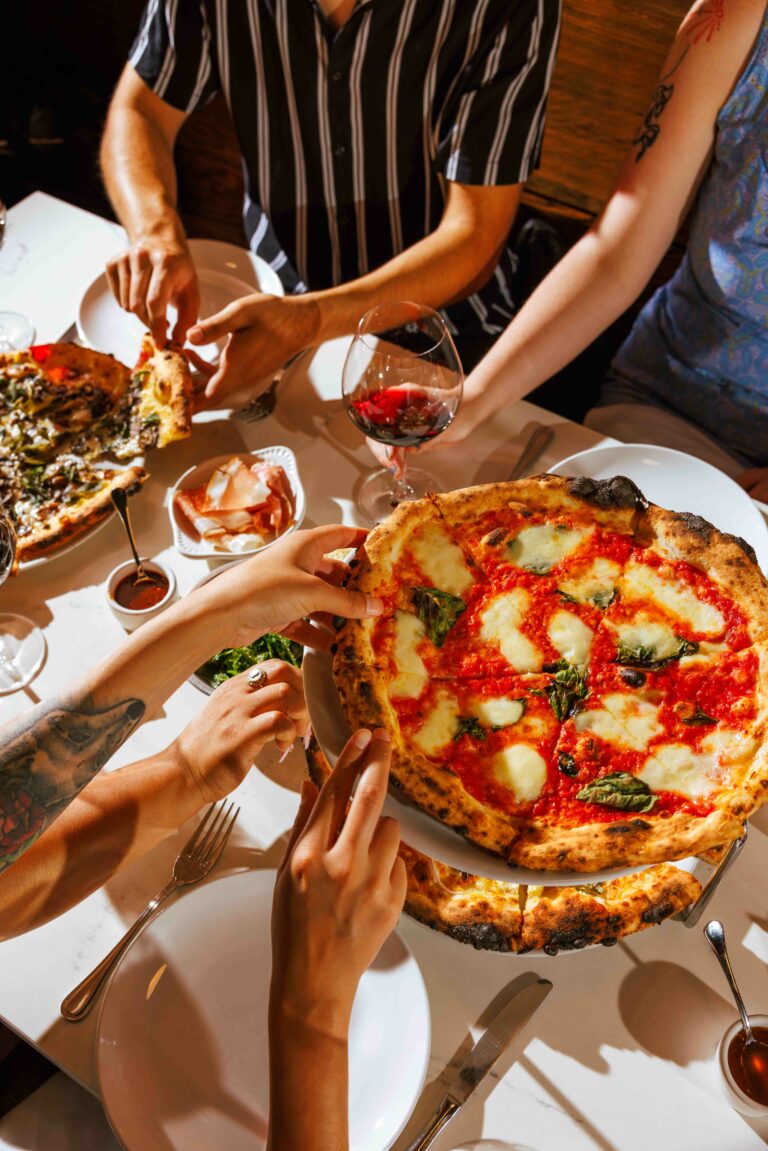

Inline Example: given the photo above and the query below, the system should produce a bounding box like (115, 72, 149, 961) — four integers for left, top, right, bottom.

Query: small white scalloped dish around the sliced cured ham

(168, 444, 306, 559)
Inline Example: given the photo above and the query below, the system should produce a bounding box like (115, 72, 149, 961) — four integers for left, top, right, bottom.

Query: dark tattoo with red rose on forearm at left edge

(0, 696, 144, 871)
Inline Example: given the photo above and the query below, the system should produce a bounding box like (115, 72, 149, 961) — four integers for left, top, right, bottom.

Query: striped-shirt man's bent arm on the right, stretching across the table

(188, 183, 520, 404)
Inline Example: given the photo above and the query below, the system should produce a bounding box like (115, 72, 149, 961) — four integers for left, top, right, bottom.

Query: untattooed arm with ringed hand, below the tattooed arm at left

(0, 660, 307, 939)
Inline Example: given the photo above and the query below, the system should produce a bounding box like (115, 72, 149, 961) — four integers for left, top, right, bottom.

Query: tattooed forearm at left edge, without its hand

(0, 595, 231, 871)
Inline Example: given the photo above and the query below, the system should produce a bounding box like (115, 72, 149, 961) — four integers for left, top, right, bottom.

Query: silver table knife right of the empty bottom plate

(406, 980, 552, 1151)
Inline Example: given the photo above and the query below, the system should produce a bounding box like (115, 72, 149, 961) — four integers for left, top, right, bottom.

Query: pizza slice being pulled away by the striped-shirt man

(131, 335, 195, 449)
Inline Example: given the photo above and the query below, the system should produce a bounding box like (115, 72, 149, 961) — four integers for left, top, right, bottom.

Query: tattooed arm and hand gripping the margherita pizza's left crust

(0, 527, 381, 871)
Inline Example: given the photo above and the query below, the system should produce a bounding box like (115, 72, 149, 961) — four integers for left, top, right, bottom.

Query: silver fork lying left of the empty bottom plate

(61, 800, 239, 1023)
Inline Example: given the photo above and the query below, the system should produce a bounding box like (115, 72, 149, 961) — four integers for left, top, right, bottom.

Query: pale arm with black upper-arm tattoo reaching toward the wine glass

(405, 0, 765, 451)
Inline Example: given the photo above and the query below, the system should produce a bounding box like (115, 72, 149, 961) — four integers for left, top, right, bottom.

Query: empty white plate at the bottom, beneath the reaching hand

(97, 871, 429, 1151)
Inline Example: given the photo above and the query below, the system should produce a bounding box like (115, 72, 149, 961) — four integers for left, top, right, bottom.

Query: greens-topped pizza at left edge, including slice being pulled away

(0, 340, 192, 562)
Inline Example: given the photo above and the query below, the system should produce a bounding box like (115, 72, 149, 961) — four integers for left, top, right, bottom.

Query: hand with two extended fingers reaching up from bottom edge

(271, 730, 406, 1041)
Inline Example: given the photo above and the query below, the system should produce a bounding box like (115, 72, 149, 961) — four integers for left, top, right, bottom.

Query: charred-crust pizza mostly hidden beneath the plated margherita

(306, 741, 701, 955)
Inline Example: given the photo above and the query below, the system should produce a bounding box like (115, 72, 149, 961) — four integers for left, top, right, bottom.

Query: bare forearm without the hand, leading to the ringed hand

(0, 749, 203, 939)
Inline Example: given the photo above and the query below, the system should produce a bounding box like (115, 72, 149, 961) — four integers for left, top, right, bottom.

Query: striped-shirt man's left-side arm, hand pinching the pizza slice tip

(101, 64, 200, 346)
